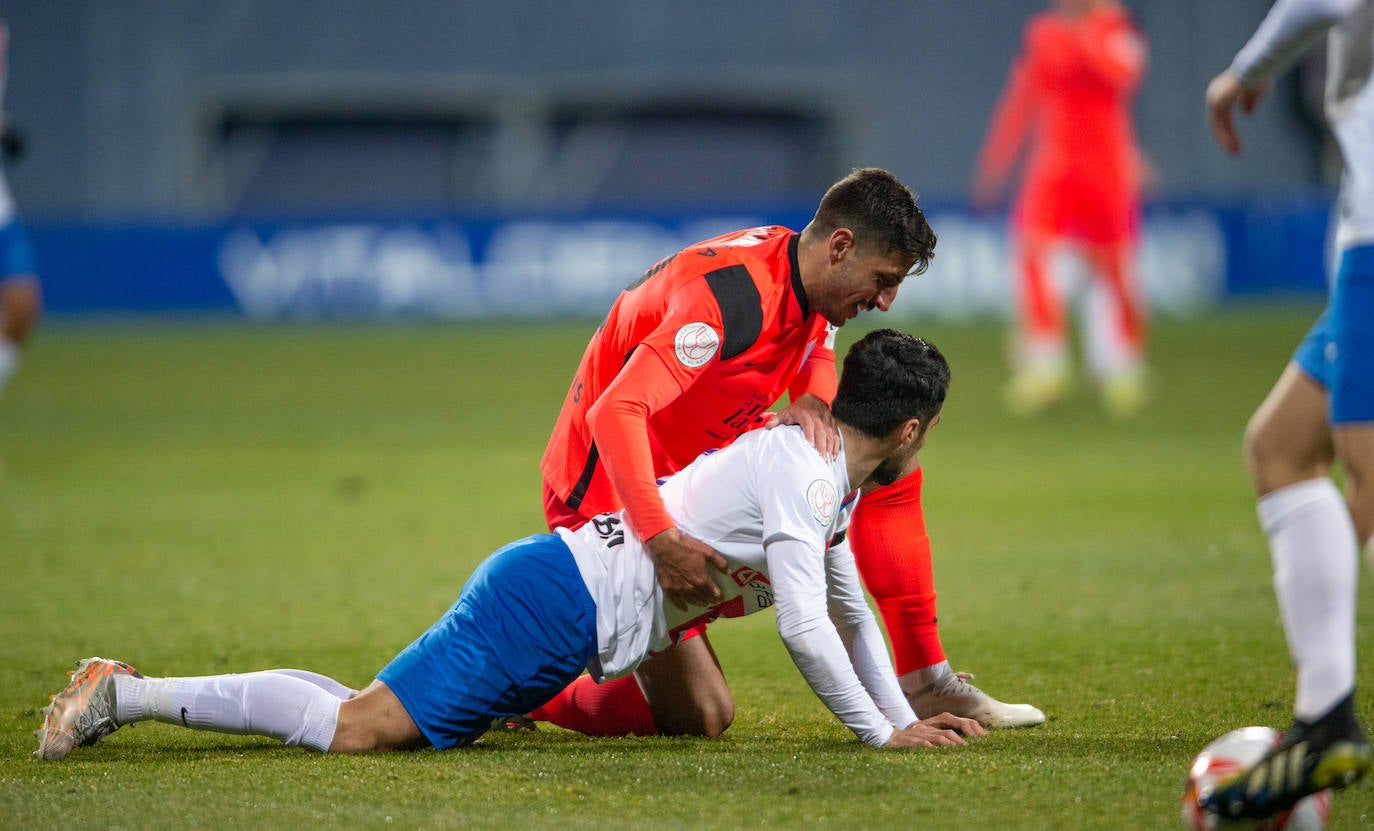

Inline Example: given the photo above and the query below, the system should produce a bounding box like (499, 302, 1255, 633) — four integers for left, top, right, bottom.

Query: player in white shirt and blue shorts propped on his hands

(38, 330, 984, 760)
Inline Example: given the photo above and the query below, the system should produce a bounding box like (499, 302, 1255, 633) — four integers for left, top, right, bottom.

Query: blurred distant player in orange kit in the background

(973, 0, 1149, 416)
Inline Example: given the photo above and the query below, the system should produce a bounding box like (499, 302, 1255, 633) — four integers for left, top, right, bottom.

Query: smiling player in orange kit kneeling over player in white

(530, 168, 1044, 736)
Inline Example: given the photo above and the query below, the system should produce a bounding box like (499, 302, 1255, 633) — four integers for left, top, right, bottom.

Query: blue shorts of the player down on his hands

(376, 534, 596, 750)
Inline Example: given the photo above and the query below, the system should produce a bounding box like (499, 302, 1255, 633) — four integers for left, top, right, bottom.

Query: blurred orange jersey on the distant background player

(980, 4, 1146, 242)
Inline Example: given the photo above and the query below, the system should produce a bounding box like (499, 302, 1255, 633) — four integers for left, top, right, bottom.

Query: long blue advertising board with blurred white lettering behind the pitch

(30, 196, 1329, 320)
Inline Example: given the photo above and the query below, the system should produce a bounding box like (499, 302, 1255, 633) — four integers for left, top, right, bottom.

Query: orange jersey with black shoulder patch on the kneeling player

(541, 225, 835, 540)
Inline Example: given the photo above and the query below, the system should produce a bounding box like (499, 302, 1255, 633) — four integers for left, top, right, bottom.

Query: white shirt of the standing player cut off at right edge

(1231, 0, 1374, 250)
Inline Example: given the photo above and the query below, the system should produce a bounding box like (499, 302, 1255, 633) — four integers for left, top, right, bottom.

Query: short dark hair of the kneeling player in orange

(812, 168, 936, 275)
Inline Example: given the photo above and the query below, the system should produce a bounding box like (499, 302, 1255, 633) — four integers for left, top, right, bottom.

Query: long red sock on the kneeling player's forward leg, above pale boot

(849, 467, 945, 676)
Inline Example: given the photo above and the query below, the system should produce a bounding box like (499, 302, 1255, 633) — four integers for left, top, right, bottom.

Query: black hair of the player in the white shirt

(830, 328, 949, 438)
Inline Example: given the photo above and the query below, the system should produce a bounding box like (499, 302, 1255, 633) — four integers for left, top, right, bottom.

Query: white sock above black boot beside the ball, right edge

(1259, 478, 1359, 721)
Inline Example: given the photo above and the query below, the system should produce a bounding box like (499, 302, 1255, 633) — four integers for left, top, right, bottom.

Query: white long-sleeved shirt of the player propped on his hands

(558, 427, 916, 746)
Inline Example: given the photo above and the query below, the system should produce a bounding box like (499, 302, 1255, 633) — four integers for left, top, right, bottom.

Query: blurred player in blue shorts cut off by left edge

(0, 21, 41, 401)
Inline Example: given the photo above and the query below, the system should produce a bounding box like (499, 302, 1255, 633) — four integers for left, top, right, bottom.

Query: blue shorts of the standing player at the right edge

(1293, 240, 1374, 424)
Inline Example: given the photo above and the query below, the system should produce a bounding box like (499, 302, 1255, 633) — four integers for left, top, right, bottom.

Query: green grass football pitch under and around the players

(0, 308, 1374, 831)
